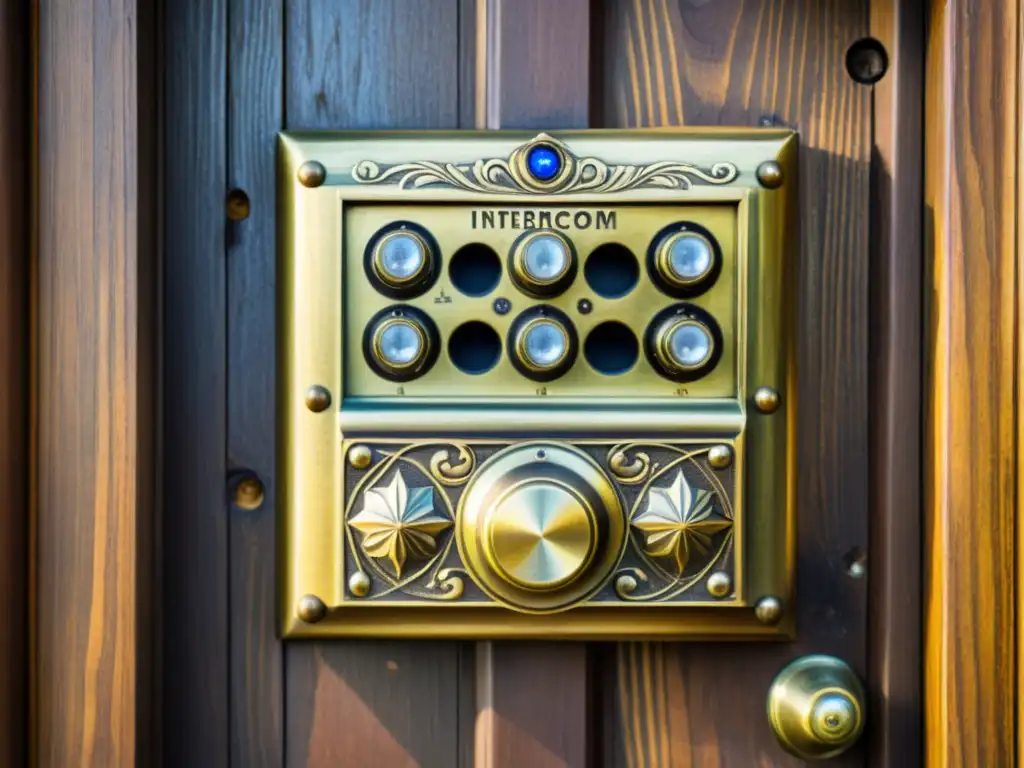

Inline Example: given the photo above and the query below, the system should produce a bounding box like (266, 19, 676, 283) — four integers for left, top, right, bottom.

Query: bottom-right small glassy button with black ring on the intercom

(646, 304, 722, 381)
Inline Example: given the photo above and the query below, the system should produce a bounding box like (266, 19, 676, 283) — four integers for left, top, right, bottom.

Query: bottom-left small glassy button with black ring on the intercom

(364, 306, 438, 381)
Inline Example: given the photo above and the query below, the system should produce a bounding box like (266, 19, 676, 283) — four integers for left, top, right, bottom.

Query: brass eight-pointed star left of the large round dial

(348, 471, 452, 579)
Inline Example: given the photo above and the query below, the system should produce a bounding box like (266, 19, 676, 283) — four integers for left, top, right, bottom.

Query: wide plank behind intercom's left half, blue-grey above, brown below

(285, 0, 467, 768)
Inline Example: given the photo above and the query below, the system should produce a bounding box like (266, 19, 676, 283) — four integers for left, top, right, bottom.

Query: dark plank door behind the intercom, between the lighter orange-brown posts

(155, 0, 922, 768)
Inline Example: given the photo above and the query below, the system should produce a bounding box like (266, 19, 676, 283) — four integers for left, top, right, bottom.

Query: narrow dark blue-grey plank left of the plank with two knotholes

(163, 0, 231, 766)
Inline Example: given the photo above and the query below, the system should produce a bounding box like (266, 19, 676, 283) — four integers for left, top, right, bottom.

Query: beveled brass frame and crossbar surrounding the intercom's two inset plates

(278, 129, 798, 639)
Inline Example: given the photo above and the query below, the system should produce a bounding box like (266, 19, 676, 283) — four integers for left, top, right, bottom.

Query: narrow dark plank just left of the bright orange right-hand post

(861, 0, 925, 768)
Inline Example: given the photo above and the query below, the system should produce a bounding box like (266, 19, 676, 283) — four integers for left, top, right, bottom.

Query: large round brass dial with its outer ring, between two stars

(456, 442, 626, 612)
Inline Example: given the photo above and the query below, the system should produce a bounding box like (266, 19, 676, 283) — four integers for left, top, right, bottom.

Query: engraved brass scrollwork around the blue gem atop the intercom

(352, 133, 739, 195)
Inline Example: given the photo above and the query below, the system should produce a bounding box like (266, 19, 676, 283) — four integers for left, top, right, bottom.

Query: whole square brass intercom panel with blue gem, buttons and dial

(279, 129, 798, 639)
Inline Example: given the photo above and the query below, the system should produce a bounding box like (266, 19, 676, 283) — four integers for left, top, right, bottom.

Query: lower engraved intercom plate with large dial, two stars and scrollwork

(345, 441, 742, 613)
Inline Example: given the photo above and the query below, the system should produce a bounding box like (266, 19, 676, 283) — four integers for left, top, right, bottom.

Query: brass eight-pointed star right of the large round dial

(633, 470, 732, 573)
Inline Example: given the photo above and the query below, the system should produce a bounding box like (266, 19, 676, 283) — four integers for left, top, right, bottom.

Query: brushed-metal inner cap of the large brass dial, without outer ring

(487, 480, 597, 590)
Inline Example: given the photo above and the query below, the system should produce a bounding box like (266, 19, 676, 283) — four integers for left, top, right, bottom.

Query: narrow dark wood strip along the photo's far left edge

(0, 0, 33, 766)
